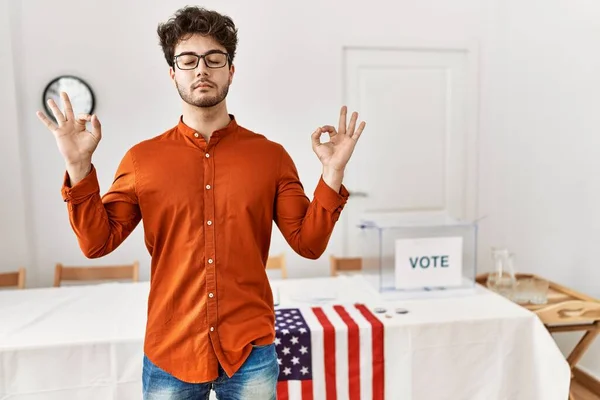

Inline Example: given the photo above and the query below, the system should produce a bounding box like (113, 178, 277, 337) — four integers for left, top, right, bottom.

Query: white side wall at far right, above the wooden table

(496, 0, 600, 382)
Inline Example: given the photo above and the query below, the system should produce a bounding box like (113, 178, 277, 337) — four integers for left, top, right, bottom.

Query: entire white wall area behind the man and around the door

(0, 0, 600, 382)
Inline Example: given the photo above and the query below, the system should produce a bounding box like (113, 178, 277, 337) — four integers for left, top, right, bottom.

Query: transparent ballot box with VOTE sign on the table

(358, 215, 477, 297)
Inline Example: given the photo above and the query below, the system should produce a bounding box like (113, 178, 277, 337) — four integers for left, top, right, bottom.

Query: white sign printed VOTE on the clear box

(396, 237, 463, 289)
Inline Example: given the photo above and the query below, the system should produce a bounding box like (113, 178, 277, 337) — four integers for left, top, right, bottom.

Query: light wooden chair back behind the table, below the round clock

(54, 261, 140, 287)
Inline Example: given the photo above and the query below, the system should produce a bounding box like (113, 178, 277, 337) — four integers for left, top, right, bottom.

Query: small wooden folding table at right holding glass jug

(477, 274, 600, 400)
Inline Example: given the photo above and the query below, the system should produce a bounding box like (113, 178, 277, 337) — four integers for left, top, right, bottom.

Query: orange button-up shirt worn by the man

(62, 115, 348, 382)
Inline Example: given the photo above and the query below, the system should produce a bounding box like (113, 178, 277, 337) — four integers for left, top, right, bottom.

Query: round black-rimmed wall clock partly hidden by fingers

(42, 75, 95, 119)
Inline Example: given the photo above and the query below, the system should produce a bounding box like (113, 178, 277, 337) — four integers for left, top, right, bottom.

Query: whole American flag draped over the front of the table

(275, 304, 384, 400)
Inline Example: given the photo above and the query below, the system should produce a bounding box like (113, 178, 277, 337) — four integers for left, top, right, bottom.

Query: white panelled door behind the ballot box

(336, 43, 477, 257)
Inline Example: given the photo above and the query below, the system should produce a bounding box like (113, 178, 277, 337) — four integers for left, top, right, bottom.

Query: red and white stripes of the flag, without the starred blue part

(277, 305, 384, 400)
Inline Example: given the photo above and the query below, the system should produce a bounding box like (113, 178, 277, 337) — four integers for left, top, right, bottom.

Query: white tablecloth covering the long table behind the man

(0, 276, 570, 400)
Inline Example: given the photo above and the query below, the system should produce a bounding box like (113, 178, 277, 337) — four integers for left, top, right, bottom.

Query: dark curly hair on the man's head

(157, 6, 237, 67)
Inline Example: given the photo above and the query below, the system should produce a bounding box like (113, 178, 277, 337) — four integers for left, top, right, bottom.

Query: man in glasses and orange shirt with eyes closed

(38, 7, 365, 400)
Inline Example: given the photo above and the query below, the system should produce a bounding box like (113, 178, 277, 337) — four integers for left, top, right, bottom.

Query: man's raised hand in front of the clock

(37, 92, 102, 186)
